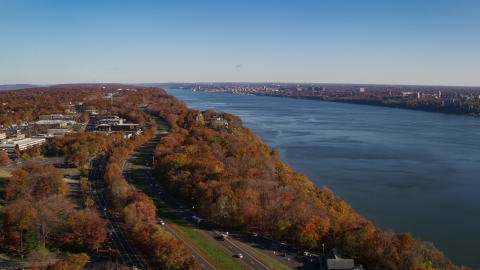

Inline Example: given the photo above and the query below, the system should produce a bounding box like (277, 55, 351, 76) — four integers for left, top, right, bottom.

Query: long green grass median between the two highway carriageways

(131, 153, 245, 270)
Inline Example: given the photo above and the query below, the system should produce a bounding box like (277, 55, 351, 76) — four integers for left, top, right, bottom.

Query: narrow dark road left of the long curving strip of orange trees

(88, 157, 146, 269)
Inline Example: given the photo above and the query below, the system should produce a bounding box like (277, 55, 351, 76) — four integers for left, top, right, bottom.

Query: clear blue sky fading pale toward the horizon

(0, 0, 480, 86)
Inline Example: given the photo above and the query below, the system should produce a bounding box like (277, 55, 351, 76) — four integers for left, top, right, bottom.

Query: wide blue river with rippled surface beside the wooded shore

(167, 89, 480, 268)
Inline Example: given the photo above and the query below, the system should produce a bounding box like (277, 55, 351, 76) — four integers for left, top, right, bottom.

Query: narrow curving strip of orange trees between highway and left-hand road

(105, 134, 200, 269)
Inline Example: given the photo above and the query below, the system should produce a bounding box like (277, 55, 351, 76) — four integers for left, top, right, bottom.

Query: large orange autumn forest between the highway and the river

(149, 93, 468, 269)
